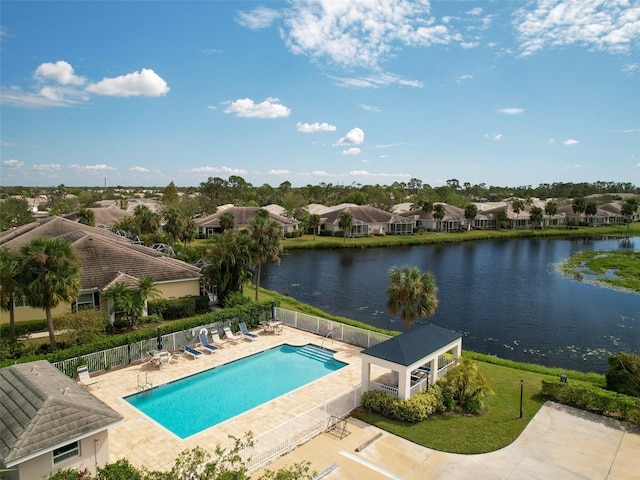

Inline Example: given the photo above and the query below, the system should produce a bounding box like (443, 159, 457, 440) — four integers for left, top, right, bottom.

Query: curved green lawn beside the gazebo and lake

(354, 362, 552, 454)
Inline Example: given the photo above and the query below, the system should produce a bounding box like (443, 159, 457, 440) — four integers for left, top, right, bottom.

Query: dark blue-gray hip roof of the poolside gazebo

(362, 324, 462, 367)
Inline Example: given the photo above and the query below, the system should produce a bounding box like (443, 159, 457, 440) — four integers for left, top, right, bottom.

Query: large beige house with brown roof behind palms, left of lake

(0, 217, 202, 321)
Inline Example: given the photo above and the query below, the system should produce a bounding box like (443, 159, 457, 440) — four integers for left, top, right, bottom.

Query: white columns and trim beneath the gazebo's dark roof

(361, 337, 462, 400)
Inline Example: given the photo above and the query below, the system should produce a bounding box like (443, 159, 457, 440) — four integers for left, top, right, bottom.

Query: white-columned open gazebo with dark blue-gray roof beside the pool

(361, 324, 462, 399)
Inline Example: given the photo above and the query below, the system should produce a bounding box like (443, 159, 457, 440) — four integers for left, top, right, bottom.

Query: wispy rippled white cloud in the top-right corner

(514, 0, 640, 56)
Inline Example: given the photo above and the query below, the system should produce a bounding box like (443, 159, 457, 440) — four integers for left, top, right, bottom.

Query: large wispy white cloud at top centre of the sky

(281, 0, 460, 70)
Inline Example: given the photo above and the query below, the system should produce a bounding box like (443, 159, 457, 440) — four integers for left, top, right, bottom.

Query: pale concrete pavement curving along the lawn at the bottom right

(255, 402, 640, 480)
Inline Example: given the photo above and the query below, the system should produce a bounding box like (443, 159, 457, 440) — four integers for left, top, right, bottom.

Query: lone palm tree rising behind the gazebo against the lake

(387, 265, 438, 331)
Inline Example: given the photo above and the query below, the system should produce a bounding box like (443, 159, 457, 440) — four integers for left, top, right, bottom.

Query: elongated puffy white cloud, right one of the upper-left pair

(86, 68, 170, 97)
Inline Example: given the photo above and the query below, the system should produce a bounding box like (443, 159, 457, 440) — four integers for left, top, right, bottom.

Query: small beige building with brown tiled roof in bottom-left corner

(0, 360, 122, 480)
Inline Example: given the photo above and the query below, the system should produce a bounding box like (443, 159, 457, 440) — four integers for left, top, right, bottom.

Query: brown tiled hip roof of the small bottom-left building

(0, 360, 122, 467)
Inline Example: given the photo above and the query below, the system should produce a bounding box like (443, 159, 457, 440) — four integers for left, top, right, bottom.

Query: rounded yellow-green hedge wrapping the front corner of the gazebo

(360, 384, 446, 423)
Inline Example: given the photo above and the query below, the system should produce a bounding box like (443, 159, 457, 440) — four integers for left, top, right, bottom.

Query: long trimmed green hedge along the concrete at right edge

(542, 380, 640, 425)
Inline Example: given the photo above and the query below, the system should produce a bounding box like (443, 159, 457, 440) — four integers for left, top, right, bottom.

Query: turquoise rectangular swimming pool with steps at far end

(124, 344, 347, 438)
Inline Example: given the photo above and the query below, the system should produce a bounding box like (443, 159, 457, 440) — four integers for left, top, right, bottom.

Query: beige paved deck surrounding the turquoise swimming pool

(86, 326, 362, 470)
